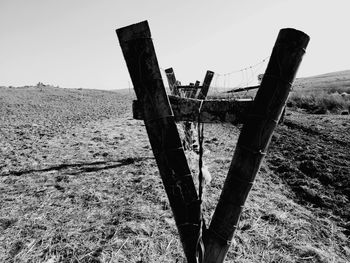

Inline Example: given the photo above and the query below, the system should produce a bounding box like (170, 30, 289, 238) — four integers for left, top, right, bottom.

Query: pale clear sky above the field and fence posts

(0, 0, 350, 89)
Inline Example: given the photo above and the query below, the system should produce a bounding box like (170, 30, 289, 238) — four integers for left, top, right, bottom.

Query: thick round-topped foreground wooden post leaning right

(204, 28, 309, 263)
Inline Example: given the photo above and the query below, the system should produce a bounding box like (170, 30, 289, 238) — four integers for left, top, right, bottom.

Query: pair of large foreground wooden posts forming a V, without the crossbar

(117, 21, 309, 263)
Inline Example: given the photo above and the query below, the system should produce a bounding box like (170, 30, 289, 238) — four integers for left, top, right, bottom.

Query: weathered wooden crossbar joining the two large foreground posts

(133, 96, 253, 124)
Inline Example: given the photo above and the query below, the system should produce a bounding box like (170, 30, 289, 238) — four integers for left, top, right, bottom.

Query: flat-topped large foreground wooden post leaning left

(116, 21, 200, 263)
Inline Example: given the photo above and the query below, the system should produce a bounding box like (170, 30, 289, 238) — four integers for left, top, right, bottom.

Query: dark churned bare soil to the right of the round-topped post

(267, 112, 350, 236)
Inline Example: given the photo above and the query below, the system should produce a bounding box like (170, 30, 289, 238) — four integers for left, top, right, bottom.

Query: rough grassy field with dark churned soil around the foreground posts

(0, 86, 350, 263)
